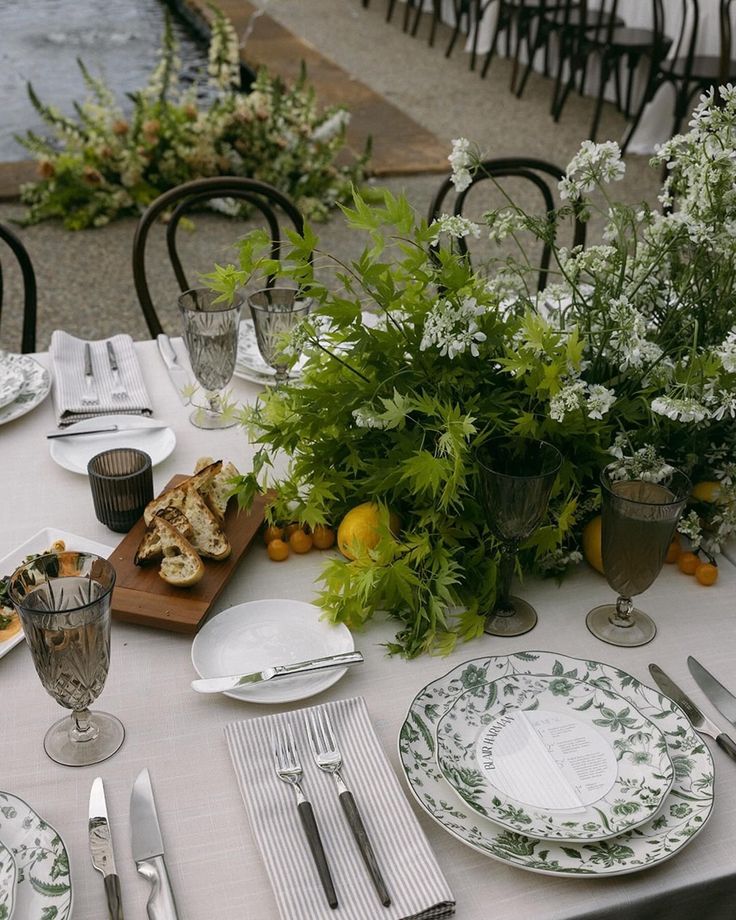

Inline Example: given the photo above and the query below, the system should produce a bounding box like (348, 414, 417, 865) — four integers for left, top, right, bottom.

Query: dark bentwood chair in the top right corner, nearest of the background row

(621, 0, 736, 151)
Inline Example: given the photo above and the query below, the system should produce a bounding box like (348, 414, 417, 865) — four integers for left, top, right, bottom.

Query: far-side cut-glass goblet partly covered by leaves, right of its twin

(248, 287, 312, 386)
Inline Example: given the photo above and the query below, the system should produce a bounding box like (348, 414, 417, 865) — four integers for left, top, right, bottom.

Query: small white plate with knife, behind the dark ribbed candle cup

(49, 415, 176, 476)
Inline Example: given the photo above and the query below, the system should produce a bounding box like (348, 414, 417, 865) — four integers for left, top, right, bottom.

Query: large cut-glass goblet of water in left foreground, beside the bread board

(9, 552, 125, 767)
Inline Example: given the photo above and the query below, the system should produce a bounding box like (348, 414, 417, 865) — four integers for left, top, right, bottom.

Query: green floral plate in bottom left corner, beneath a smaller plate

(0, 792, 72, 920)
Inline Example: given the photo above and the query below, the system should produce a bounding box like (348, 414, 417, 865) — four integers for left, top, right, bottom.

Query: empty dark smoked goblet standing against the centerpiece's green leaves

(478, 436, 562, 636)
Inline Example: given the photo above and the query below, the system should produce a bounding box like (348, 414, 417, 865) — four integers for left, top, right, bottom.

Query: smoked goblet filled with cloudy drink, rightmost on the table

(585, 464, 690, 647)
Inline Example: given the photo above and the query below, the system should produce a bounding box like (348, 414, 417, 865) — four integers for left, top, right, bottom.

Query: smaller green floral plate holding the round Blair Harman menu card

(437, 674, 675, 842)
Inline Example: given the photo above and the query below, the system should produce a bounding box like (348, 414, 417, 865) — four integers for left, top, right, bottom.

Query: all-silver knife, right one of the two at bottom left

(130, 769, 179, 920)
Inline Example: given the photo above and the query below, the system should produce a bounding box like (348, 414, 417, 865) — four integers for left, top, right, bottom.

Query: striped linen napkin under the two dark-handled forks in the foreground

(225, 697, 455, 920)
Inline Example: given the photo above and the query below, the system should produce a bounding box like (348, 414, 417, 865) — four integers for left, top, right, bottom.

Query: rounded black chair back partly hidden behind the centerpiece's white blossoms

(427, 157, 585, 291)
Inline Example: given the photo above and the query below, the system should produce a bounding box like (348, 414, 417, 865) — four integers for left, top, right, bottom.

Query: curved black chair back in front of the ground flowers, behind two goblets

(133, 176, 304, 337)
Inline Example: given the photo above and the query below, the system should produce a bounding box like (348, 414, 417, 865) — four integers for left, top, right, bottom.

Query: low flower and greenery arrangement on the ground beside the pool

(17, 7, 369, 230)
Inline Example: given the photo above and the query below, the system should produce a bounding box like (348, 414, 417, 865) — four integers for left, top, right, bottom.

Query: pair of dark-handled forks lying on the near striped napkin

(271, 710, 391, 910)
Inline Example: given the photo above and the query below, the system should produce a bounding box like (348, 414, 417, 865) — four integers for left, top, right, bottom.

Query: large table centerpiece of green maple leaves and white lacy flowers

(209, 87, 736, 656)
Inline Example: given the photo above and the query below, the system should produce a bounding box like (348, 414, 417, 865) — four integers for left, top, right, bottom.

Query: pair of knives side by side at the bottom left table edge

(89, 769, 178, 920)
